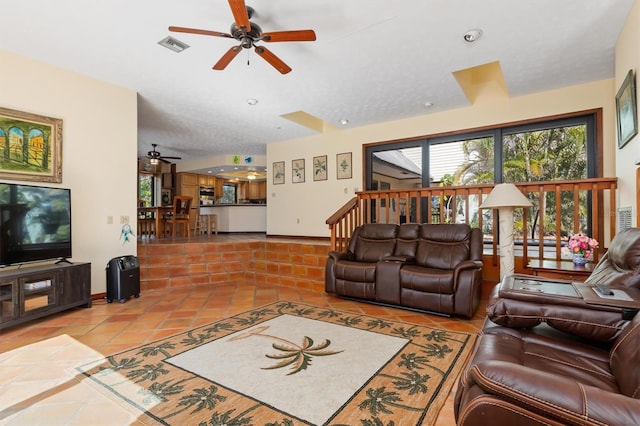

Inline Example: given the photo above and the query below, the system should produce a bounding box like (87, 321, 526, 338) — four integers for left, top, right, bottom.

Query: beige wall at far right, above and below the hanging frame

(614, 1, 640, 226)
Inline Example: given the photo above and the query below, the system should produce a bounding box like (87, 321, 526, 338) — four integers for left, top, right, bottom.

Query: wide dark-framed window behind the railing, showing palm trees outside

(365, 113, 601, 238)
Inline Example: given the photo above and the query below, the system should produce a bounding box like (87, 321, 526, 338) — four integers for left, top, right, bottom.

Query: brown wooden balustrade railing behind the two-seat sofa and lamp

(326, 178, 617, 264)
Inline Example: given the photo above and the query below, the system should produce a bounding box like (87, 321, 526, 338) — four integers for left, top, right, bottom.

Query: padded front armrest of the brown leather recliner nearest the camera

(469, 361, 640, 425)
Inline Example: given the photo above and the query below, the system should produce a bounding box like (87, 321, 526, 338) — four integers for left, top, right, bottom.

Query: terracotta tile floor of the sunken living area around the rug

(0, 283, 484, 425)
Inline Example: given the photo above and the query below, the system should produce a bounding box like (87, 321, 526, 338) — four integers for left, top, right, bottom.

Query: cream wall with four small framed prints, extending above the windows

(267, 77, 620, 236)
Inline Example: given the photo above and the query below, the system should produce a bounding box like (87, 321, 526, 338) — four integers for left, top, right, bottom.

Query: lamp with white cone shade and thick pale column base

(480, 183, 532, 282)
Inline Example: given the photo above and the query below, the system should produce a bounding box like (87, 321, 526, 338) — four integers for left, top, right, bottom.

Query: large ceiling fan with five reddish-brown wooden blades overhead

(169, 0, 316, 74)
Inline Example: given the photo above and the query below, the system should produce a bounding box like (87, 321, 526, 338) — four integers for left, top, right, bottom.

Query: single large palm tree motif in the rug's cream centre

(229, 325, 343, 376)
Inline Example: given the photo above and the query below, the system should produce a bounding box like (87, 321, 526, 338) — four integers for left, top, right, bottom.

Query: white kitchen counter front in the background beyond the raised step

(200, 204, 267, 232)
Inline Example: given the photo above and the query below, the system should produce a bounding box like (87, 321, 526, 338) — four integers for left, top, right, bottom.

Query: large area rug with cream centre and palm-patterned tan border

(78, 302, 475, 426)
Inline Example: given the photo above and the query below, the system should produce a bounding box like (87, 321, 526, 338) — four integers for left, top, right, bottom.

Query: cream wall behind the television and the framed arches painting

(0, 50, 137, 294)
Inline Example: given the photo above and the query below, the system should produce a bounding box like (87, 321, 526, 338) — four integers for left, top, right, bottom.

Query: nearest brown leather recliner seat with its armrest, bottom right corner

(454, 315, 640, 426)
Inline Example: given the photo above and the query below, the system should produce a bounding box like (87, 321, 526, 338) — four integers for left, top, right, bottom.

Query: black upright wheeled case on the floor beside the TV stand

(106, 256, 140, 303)
